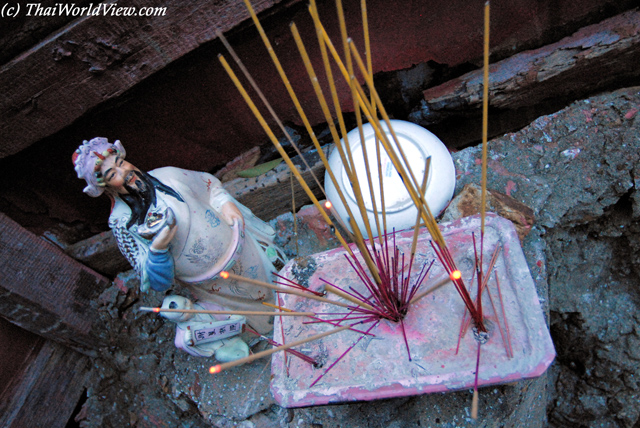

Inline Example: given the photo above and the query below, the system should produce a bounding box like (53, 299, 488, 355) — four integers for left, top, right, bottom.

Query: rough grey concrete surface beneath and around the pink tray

(77, 88, 640, 428)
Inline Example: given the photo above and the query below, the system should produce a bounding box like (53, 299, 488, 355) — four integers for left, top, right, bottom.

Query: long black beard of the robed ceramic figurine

(120, 171, 184, 229)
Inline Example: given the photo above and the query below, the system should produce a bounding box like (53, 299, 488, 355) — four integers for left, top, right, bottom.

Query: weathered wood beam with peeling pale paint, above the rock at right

(415, 11, 640, 126)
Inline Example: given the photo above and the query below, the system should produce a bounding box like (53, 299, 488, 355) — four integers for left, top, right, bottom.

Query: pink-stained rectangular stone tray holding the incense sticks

(271, 214, 555, 407)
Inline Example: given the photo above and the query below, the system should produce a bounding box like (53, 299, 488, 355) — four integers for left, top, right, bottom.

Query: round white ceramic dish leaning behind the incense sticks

(324, 120, 456, 237)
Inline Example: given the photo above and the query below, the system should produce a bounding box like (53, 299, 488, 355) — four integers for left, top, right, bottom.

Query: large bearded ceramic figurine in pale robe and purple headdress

(73, 137, 284, 354)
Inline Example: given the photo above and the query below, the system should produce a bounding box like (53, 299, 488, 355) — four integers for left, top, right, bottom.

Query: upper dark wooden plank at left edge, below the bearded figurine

(0, 214, 109, 355)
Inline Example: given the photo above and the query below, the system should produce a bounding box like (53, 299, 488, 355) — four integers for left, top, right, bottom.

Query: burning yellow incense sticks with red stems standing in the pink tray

(211, 0, 508, 417)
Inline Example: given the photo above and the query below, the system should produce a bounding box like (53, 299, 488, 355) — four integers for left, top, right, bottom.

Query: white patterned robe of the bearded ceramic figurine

(109, 167, 275, 333)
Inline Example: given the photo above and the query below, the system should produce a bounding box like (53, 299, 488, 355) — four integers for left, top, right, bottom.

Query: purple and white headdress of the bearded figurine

(71, 137, 127, 198)
